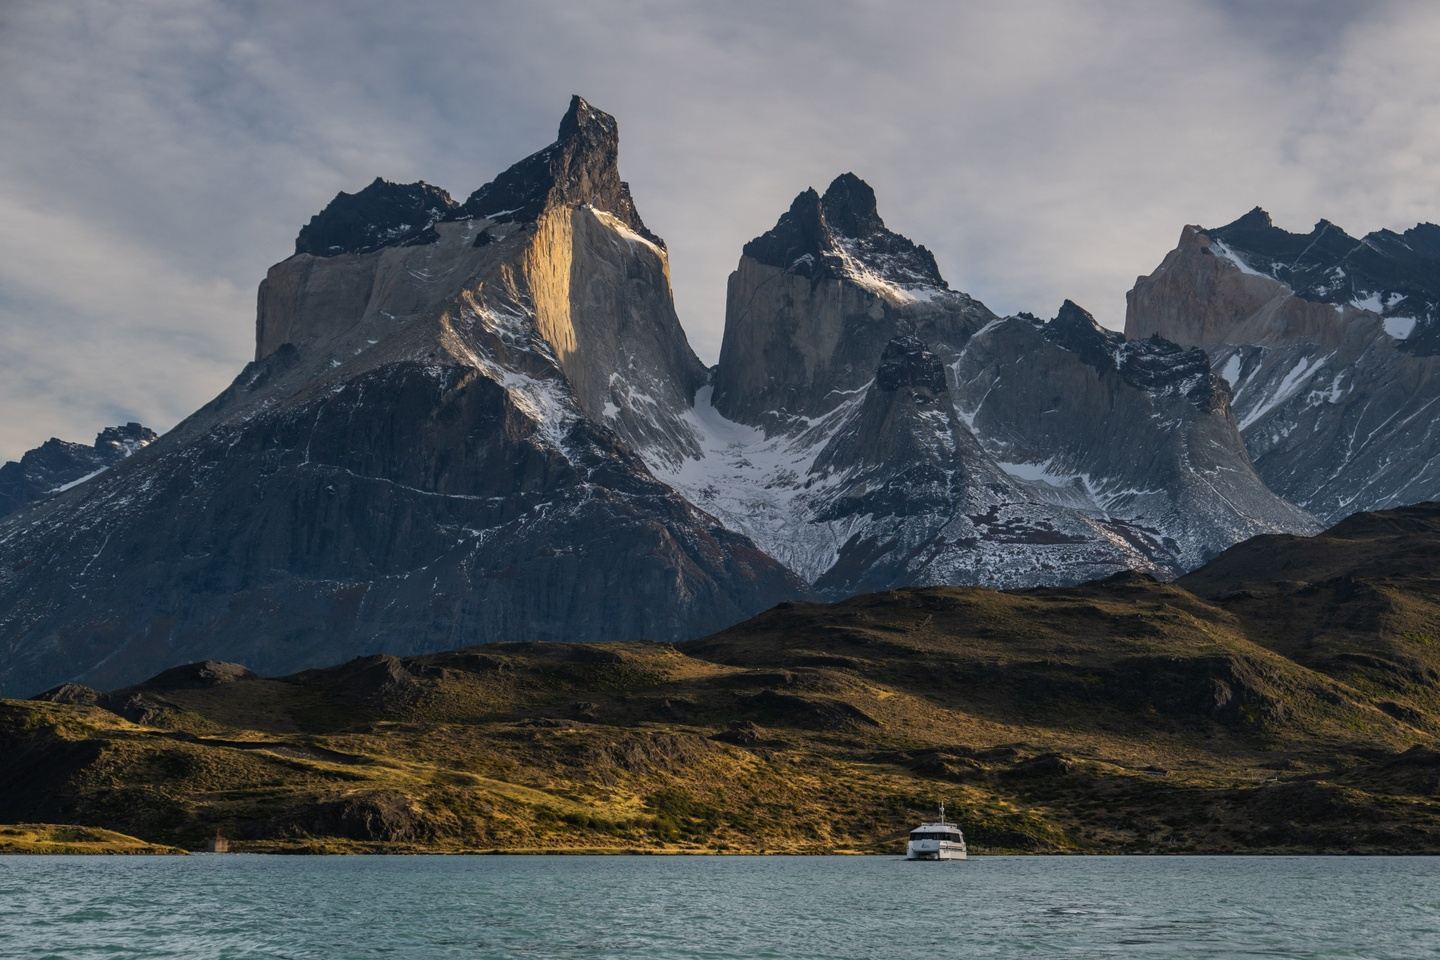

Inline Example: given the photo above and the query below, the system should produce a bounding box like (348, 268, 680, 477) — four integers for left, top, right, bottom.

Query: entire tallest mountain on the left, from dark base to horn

(0, 99, 804, 691)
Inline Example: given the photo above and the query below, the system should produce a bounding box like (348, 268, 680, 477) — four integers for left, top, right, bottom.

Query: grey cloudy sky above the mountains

(0, 0, 1440, 458)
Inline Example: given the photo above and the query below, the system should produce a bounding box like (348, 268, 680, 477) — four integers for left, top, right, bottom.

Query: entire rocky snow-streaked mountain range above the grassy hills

(0, 96, 1440, 692)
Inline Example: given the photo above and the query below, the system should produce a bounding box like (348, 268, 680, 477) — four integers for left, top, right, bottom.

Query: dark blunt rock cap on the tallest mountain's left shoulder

(295, 177, 458, 256)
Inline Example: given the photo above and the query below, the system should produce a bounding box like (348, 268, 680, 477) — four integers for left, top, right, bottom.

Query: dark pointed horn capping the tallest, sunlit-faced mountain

(458, 95, 664, 246)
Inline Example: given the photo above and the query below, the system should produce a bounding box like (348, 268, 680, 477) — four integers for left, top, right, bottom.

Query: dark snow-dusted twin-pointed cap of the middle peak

(743, 173, 949, 291)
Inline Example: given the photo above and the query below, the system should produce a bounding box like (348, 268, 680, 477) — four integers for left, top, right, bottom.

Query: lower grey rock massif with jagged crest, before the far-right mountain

(955, 302, 1316, 571)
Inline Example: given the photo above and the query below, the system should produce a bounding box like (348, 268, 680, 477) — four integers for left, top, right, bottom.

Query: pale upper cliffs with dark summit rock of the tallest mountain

(256, 98, 706, 455)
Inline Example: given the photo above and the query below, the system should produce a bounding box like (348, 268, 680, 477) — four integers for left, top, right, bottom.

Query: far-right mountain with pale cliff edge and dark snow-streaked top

(1125, 209, 1440, 521)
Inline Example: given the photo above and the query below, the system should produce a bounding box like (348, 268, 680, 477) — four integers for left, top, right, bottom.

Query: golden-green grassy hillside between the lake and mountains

(0, 505, 1440, 852)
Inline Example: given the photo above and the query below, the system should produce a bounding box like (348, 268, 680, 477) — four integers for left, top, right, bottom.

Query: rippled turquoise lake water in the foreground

(0, 855, 1440, 960)
